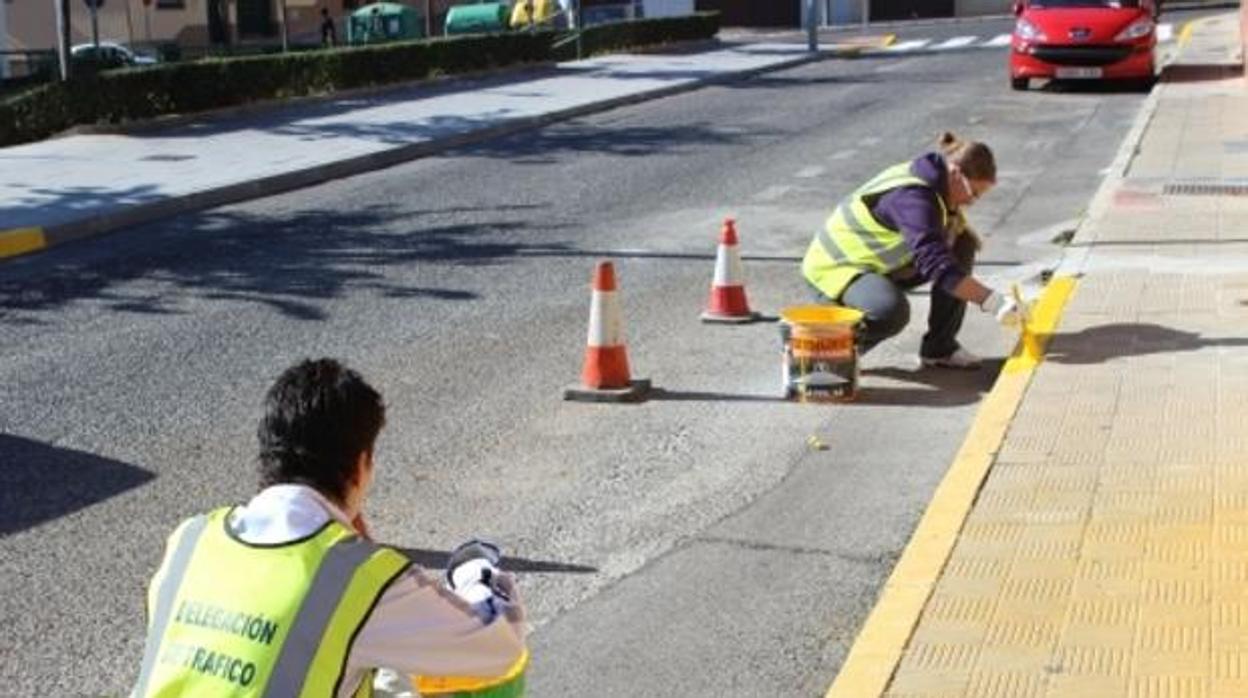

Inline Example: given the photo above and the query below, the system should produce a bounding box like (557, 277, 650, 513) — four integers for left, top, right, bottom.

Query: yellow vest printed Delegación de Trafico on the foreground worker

(134, 509, 411, 698)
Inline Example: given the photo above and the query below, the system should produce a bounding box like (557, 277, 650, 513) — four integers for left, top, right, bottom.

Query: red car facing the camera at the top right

(1010, 0, 1159, 90)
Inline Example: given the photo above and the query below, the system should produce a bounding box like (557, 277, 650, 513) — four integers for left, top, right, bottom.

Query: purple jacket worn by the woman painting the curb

(866, 152, 966, 291)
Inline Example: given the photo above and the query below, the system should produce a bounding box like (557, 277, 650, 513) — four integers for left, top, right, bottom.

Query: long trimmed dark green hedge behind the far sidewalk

(0, 11, 719, 146)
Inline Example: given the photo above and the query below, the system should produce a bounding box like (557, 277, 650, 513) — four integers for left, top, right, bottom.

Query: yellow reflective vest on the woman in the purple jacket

(801, 162, 948, 300)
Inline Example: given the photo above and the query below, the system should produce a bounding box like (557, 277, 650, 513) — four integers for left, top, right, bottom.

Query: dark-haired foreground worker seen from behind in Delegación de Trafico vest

(134, 358, 527, 698)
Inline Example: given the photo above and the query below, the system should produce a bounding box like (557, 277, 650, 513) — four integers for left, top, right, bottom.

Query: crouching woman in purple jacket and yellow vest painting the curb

(801, 134, 1022, 368)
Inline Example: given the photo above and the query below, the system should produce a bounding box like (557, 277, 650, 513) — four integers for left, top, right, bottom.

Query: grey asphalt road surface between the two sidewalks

(0, 19, 1163, 697)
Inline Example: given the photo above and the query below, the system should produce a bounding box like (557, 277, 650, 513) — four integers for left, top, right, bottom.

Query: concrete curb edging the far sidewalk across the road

(0, 49, 861, 260)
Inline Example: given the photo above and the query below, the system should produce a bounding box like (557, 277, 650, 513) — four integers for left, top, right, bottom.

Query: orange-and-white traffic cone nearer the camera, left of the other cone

(564, 262, 650, 402)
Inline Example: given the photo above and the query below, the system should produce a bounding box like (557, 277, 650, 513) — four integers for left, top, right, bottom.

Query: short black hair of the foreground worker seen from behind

(257, 358, 386, 502)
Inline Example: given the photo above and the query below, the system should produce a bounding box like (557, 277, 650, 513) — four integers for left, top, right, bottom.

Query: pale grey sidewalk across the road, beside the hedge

(0, 44, 878, 260)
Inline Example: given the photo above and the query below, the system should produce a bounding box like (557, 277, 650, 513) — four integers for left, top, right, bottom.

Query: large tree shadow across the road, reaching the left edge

(0, 205, 569, 323)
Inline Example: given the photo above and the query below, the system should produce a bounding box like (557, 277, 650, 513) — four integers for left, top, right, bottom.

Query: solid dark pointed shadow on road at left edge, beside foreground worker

(0, 433, 156, 536)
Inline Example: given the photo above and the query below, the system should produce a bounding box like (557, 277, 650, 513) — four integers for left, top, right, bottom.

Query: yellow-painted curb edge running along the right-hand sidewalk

(826, 276, 1076, 698)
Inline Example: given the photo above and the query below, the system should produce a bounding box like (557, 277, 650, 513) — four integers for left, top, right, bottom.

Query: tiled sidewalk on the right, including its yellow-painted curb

(829, 10, 1248, 698)
